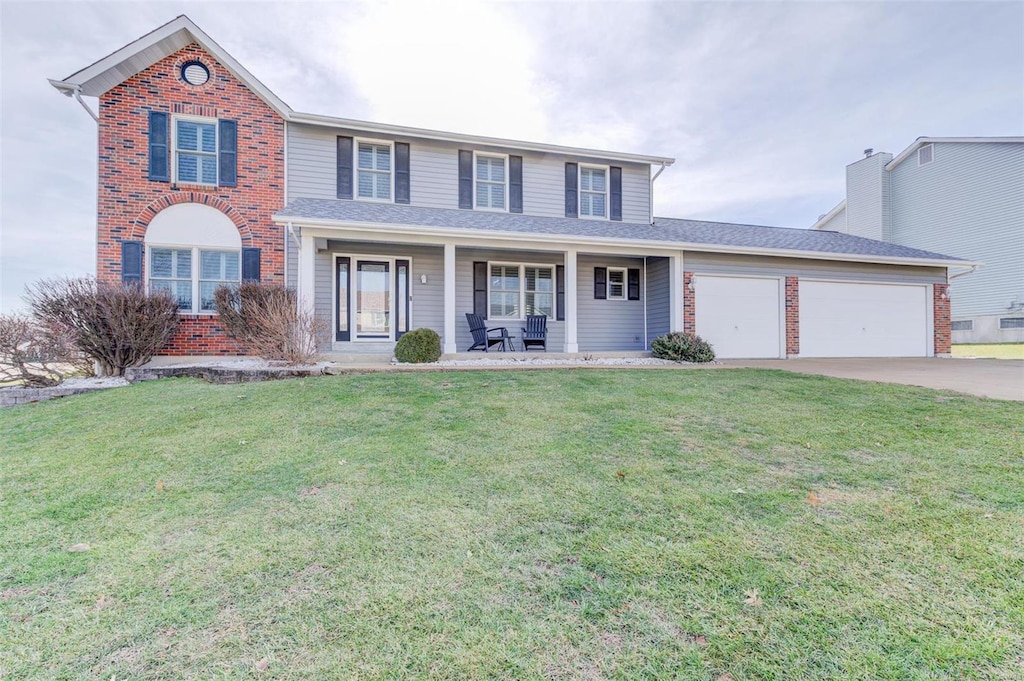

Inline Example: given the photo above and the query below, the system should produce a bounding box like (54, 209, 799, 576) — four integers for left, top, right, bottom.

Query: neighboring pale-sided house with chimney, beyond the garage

(813, 137, 1024, 343)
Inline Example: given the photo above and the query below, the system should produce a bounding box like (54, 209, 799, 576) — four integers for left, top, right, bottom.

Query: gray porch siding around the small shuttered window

(577, 255, 646, 352)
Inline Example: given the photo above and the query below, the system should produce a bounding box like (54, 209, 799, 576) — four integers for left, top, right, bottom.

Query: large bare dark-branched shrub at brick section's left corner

(26, 276, 178, 376)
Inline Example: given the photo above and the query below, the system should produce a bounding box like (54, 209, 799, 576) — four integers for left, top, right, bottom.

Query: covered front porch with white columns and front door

(288, 225, 683, 358)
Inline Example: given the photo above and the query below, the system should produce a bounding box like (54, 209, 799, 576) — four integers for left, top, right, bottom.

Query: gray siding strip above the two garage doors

(683, 251, 946, 284)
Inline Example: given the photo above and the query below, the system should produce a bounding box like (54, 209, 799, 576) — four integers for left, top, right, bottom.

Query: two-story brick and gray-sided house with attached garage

(51, 16, 966, 357)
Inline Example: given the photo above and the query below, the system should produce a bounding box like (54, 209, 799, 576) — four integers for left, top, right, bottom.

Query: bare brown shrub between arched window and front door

(214, 282, 324, 365)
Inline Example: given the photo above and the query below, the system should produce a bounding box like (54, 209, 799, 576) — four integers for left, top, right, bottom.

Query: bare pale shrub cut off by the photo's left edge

(0, 314, 91, 387)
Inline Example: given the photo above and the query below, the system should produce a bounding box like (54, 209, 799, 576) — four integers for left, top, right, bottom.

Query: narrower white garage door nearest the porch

(693, 275, 782, 357)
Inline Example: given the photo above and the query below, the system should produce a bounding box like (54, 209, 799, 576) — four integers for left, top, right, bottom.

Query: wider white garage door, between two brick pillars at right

(800, 281, 928, 357)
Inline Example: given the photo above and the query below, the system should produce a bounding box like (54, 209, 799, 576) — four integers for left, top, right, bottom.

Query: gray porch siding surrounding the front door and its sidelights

(314, 240, 444, 349)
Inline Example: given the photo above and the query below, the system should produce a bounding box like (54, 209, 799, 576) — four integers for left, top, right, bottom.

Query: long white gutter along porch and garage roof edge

(271, 215, 981, 267)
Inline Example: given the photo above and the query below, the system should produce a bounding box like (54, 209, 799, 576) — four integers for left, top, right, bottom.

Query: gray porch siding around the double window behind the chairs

(458, 248, 565, 352)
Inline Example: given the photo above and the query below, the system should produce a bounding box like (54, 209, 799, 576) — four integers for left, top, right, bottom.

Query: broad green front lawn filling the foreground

(6, 370, 1024, 681)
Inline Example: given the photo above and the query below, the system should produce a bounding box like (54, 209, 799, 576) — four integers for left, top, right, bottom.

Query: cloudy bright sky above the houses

(0, 0, 1024, 311)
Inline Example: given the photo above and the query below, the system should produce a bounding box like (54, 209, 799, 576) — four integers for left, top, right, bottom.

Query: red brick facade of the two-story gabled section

(96, 43, 285, 354)
